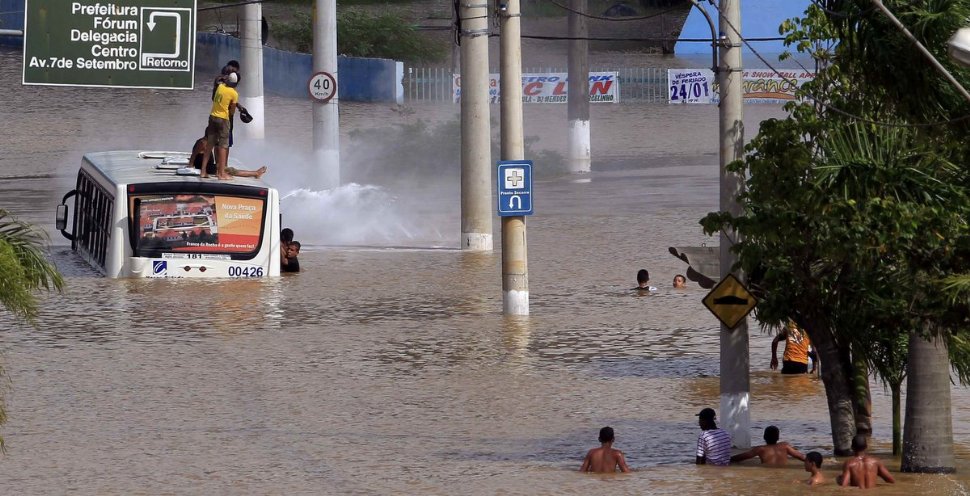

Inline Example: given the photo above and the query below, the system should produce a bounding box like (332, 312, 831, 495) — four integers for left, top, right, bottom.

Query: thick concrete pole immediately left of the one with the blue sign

(455, 0, 495, 251)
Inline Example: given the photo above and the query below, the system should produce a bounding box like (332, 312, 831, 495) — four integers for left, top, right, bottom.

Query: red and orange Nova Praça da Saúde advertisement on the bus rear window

(132, 195, 264, 253)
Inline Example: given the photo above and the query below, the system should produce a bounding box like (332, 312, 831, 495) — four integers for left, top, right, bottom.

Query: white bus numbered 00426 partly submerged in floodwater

(56, 151, 280, 278)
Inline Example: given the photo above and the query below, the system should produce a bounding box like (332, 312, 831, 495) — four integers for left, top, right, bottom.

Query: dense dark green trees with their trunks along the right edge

(701, 0, 970, 472)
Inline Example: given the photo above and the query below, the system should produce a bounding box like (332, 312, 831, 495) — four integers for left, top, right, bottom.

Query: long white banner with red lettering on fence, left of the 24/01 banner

(452, 72, 620, 103)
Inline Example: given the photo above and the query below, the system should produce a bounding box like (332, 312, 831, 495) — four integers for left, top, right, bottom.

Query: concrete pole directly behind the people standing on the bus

(233, 3, 266, 140)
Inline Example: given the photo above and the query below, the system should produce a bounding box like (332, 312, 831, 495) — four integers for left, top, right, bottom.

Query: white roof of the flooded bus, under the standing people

(84, 150, 272, 189)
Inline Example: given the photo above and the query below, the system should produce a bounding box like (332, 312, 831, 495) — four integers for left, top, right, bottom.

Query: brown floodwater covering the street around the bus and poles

(0, 48, 970, 495)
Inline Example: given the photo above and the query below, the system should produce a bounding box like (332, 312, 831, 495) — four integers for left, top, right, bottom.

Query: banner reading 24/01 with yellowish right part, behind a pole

(667, 69, 815, 104)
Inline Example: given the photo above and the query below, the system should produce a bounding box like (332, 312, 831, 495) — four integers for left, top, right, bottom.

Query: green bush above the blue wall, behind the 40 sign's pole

(275, 10, 444, 62)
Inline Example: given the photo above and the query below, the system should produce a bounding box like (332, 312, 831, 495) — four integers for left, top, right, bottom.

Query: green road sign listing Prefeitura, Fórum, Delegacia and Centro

(23, 0, 196, 90)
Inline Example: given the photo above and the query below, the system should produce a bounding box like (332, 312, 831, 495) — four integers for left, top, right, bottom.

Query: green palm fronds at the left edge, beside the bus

(0, 209, 64, 324)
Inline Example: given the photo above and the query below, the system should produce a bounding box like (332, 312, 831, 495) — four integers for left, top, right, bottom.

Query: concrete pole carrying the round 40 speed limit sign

(313, 0, 340, 188)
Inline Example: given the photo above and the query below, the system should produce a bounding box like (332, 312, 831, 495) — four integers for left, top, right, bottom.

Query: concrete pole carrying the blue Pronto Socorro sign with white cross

(498, 0, 529, 315)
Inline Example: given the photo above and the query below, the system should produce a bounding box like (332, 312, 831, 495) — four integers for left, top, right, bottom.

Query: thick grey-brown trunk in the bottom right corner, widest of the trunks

(900, 332, 956, 473)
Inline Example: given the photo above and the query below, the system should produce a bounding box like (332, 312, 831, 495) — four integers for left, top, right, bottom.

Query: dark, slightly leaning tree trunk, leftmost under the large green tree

(809, 327, 856, 456)
